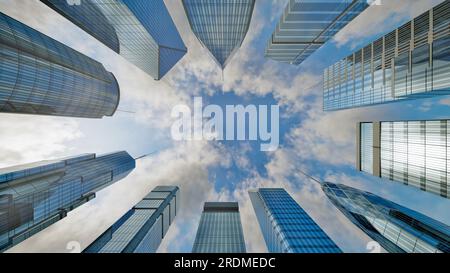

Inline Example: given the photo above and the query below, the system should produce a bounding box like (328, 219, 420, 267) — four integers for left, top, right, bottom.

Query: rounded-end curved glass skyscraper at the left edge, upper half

(0, 12, 120, 118)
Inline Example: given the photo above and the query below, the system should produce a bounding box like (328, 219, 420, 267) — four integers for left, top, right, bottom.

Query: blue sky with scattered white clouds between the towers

(0, 0, 450, 252)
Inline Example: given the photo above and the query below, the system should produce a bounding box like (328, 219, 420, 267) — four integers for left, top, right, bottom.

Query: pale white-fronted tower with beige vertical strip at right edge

(356, 120, 450, 198)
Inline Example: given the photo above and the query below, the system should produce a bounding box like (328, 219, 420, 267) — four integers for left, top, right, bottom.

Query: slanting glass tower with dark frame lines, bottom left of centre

(84, 186, 180, 253)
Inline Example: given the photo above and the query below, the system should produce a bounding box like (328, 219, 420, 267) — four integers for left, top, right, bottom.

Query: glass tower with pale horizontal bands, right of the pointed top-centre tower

(265, 0, 369, 65)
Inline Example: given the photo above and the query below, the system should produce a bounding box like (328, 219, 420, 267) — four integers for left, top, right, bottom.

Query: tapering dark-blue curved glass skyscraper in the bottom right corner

(322, 182, 450, 253)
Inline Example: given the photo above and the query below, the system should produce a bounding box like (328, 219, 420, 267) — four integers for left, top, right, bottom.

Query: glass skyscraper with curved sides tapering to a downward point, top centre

(182, 0, 256, 69)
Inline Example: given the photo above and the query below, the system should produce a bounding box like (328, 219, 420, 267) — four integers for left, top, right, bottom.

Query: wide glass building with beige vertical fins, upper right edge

(323, 0, 450, 111)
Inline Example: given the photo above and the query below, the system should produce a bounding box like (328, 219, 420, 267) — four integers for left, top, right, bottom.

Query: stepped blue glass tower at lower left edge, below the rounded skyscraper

(0, 152, 135, 251)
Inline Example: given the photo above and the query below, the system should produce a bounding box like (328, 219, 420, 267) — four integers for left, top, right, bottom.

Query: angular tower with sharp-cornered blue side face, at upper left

(41, 0, 187, 80)
